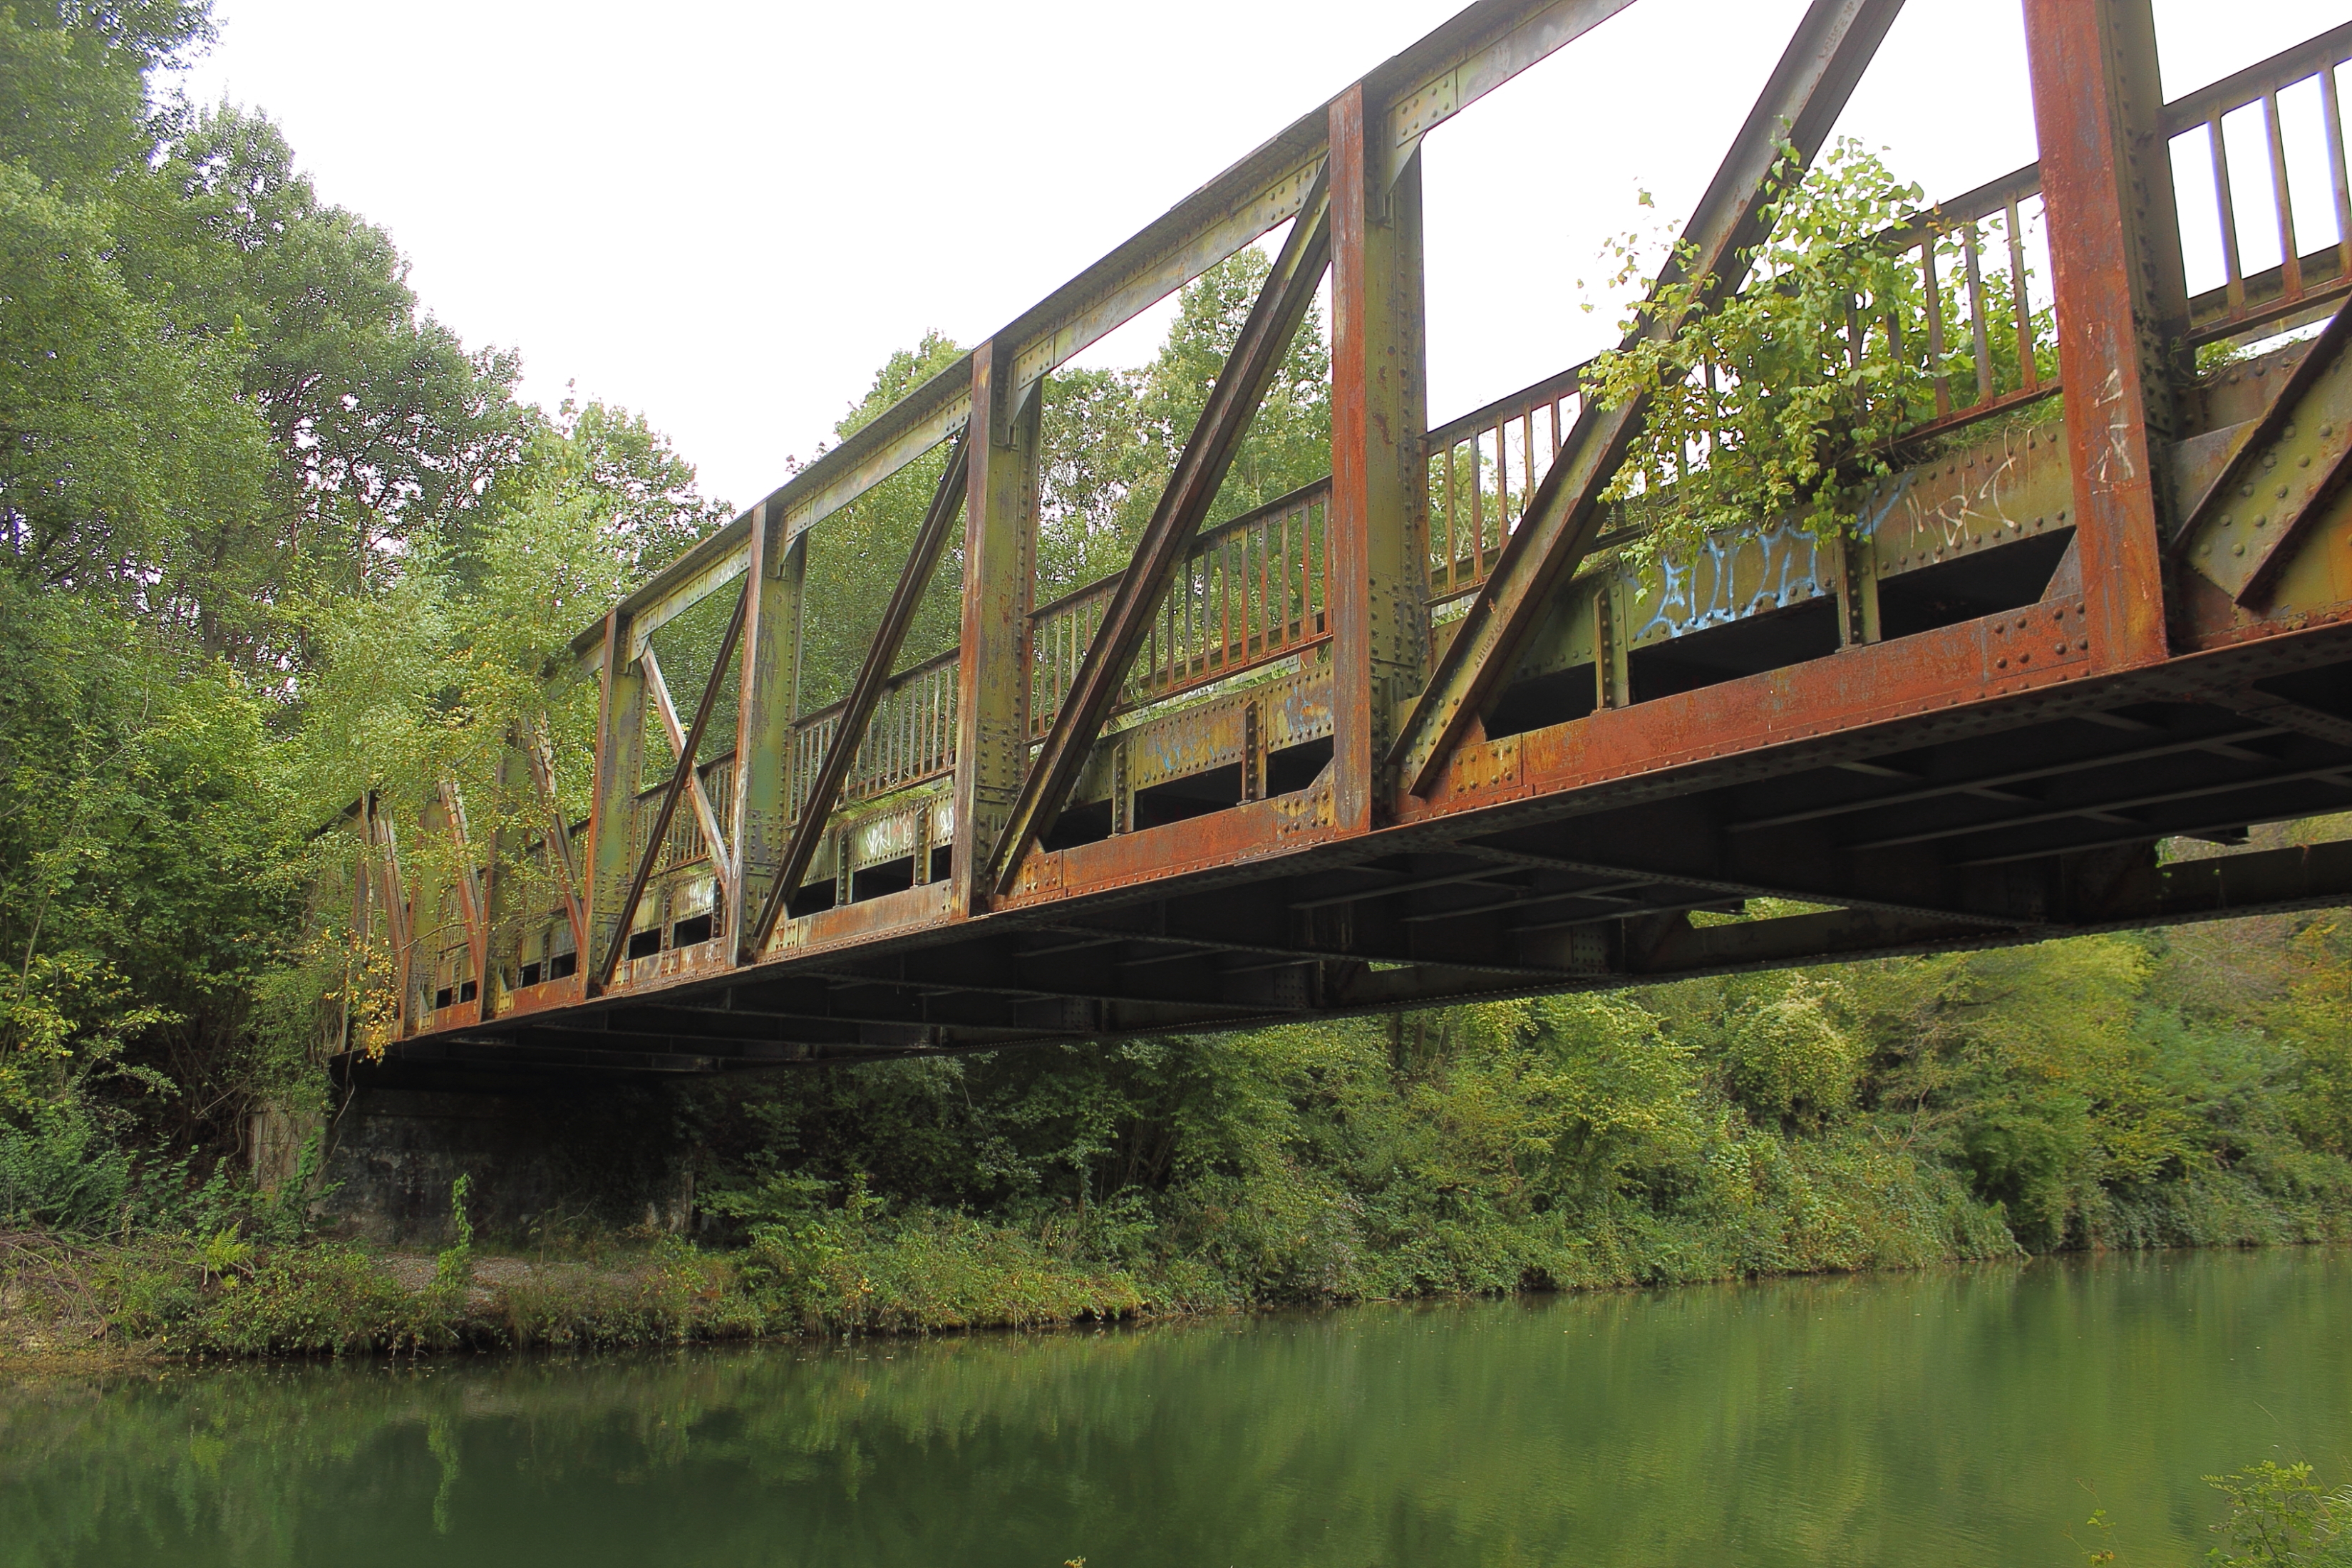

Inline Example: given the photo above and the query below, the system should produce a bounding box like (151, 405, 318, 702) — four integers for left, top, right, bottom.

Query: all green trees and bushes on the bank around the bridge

(0, 0, 2352, 1354)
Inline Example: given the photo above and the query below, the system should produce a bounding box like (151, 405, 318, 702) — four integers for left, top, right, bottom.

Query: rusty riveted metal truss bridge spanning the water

(322, 0, 2352, 1086)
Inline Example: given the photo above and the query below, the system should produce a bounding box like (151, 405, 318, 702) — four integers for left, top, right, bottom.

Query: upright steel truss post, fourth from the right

(727, 501, 809, 964)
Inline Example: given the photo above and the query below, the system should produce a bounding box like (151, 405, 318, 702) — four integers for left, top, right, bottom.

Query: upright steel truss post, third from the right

(948, 344, 1044, 917)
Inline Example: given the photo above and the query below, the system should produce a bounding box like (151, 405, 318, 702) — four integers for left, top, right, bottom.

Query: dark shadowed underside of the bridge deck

(371, 625, 2352, 1077)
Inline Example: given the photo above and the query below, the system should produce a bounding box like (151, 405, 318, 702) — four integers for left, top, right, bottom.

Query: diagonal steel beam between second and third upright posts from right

(988, 176, 1331, 898)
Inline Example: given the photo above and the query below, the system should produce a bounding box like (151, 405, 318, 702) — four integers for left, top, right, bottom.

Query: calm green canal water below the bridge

(0, 1251, 2352, 1568)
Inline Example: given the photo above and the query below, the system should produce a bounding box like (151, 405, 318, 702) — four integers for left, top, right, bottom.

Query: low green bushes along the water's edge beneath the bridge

(14, 919, 2352, 1354)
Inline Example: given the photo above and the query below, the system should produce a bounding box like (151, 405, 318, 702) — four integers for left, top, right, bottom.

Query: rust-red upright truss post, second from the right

(1326, 82, 1430, 832)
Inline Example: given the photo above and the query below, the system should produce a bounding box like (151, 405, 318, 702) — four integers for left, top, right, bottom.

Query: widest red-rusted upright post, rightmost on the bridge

(2025, 0, 2187, 670)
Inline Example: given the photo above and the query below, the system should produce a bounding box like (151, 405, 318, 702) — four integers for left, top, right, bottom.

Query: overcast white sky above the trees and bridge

(188, 0, 2352, 505)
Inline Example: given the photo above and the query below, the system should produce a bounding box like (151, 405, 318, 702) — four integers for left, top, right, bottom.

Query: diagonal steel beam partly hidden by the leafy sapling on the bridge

(1390, 0, 1903, 795)
